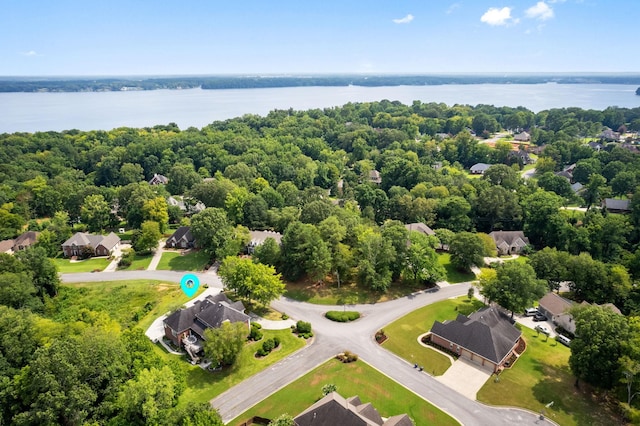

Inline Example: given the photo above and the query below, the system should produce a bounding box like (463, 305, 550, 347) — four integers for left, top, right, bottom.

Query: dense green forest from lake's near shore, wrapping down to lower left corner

(0, 100, 640, 424)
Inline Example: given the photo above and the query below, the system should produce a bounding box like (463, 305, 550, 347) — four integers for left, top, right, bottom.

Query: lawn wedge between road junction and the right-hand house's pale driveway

(383, 297, 482, 376)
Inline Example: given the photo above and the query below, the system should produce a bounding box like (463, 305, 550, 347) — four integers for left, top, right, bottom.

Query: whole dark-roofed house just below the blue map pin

(163, 293, 250, 353)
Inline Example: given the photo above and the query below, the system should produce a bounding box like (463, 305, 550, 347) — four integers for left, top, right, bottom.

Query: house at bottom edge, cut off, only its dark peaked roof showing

(293, 392, 413, 426)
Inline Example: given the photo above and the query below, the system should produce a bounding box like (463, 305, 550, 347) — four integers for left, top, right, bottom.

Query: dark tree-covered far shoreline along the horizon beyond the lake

(0, 74, 640, 93)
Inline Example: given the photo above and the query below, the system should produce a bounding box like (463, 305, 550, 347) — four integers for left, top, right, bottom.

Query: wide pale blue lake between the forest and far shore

(0, 83, 640, 133)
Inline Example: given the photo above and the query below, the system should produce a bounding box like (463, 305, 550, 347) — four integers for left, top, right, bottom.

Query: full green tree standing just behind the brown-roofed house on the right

(480, 262, 547, 317)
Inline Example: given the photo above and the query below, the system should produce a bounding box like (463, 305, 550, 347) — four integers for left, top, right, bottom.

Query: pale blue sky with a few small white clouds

(0, 0, 640, 76)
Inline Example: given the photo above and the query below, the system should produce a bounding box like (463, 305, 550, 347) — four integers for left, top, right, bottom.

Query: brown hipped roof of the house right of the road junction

(431, 307, 521, 364)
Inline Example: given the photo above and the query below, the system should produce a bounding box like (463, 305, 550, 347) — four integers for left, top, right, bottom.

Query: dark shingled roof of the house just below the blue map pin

(164, 293, 249, 338)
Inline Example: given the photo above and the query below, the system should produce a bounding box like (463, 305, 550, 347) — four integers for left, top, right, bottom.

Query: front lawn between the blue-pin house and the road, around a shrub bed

(164, 329, 306, 407)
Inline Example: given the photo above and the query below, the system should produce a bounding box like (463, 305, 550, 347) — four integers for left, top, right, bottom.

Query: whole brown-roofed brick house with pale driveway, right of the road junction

(430, 306, 522, 373)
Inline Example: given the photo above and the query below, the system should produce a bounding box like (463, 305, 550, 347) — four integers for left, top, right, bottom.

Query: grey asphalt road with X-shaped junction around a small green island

(61, 271, 538, 426)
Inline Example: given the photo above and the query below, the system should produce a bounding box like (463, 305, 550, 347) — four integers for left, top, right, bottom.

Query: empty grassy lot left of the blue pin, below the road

(47, 280, 203, 330)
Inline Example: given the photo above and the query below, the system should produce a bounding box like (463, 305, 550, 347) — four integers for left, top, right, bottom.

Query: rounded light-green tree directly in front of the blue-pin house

(204, 322, 249, 365)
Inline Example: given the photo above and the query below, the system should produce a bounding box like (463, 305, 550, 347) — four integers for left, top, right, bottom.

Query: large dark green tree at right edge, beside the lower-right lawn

(569, 306, 629, 389)
